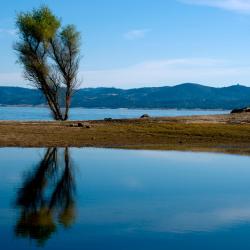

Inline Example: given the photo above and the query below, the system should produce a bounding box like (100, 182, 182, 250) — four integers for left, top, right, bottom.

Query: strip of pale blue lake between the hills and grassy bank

(0, 107, 229, 121)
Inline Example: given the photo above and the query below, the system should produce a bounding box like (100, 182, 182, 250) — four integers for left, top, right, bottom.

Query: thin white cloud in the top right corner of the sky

(179, 0, 250, 13)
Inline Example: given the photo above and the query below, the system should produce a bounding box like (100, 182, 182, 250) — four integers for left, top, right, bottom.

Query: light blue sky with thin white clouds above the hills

(0, 0, 250, 88)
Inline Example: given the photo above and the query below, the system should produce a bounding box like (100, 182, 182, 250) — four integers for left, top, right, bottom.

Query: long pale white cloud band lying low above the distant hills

(0, 58, 250, 88)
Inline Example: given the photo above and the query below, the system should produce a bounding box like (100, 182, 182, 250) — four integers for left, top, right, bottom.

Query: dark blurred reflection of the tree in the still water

(15, 148, 75, 245)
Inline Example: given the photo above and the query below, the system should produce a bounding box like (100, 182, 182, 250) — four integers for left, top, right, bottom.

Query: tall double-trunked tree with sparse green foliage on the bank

(14, 6, 80, 120)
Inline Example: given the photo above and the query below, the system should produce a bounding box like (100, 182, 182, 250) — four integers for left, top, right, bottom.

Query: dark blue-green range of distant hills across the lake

(0, 83, 250, 109)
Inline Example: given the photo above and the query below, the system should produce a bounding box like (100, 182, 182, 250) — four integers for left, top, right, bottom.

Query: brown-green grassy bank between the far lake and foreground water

(0, 114, 250, 154)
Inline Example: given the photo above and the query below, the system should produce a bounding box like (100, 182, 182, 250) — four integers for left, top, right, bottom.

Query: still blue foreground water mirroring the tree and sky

(0, 148, 250, 250)
